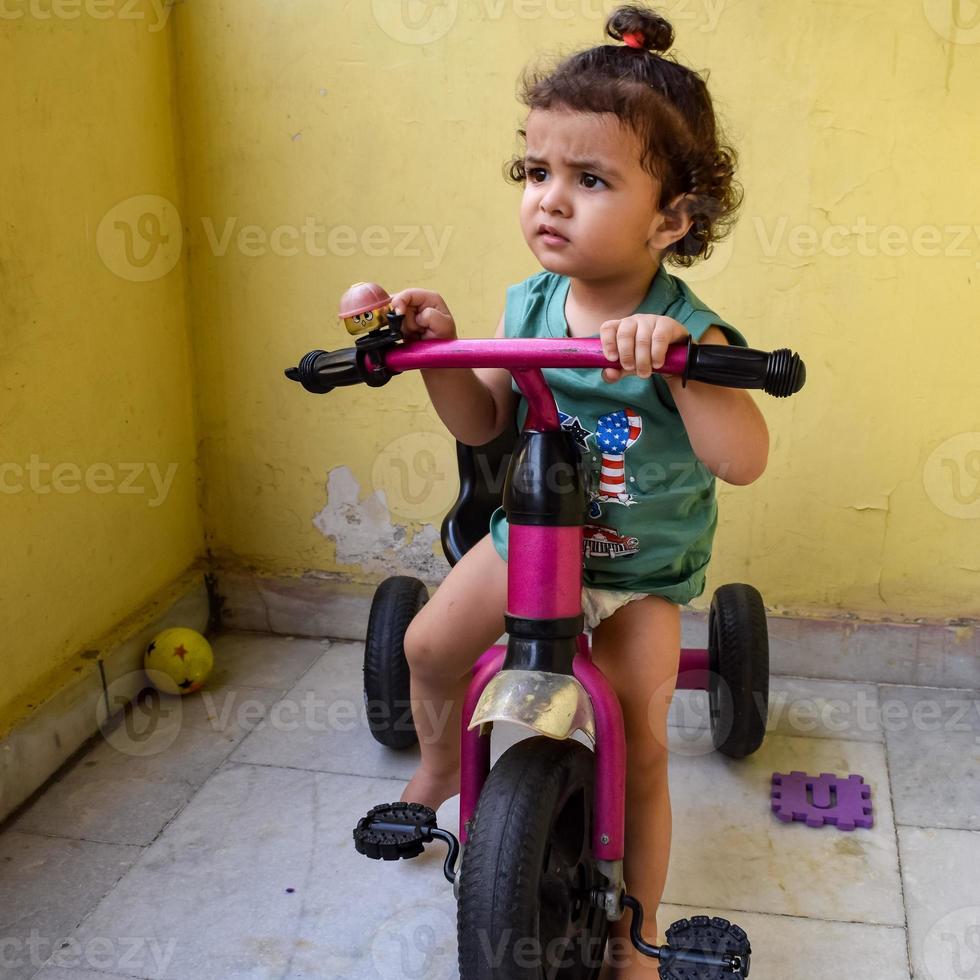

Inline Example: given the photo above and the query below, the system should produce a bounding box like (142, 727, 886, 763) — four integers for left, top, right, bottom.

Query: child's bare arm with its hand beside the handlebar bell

(391, 289, 519, 446)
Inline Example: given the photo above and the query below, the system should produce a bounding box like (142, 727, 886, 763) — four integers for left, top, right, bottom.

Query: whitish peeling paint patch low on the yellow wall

(313, 466, 448, 581)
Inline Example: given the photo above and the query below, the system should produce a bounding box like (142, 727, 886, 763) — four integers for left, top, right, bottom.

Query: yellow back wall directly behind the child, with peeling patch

(175, 0, 980, 619)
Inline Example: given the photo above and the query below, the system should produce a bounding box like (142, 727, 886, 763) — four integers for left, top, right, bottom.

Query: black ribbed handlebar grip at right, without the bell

(684, 344, 806, 398)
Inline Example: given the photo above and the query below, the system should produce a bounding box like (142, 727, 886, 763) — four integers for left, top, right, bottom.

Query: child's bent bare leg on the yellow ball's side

(401, 534, 507, 809)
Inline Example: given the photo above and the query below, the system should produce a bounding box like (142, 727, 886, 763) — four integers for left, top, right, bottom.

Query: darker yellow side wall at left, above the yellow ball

(0, 0, 203, 731)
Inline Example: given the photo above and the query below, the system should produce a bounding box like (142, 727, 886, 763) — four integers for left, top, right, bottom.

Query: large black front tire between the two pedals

(457, 735, 609, 980)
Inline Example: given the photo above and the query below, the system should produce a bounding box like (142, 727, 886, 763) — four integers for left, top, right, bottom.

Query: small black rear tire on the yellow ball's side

(364, 575, 429, 749)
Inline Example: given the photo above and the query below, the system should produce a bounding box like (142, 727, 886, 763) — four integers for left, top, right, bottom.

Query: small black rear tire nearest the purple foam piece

(708, 583, 769, 759)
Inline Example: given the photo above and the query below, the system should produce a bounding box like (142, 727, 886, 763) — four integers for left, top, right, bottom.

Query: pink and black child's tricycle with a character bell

(286, 284, 806, 980)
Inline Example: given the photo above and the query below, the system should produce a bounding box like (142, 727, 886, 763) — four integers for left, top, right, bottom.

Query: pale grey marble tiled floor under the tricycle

(0, 633, 980, 980)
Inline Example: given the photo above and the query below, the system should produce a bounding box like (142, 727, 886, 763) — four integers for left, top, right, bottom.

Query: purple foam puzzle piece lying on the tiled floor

(772, 771, 874, 830)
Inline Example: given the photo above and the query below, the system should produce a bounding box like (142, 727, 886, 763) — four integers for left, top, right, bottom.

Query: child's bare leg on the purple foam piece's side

(592, 596, 681, 980)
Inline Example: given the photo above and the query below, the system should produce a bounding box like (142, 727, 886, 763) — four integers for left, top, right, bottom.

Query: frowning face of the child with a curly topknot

(521, 109, 669, 279)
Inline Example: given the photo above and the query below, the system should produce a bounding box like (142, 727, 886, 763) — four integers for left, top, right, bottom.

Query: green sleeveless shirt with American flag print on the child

(490, 266, 748, 604)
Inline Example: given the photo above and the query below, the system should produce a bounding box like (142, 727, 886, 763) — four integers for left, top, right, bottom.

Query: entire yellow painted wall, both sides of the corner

(0, 0, 980, 736)
